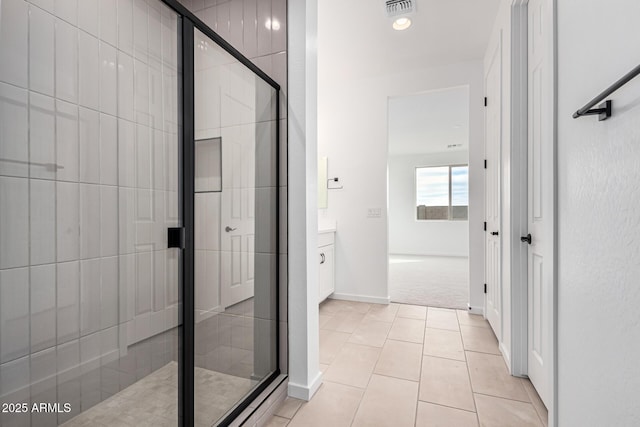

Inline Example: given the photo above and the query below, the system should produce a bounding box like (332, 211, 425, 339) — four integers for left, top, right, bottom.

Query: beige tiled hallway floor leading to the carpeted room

(268, 300, 547, 427)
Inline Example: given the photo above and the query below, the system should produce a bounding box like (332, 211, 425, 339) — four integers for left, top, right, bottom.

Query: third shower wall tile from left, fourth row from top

(56, 261, 80, 344)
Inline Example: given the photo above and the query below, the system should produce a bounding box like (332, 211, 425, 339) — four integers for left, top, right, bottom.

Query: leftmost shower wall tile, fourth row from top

(0, 268, 29, 362)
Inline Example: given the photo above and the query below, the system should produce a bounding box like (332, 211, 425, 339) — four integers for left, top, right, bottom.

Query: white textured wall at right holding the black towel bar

(557, 0, 640, 426)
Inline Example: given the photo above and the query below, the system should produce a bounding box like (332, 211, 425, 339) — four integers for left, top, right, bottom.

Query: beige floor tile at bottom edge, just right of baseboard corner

(289, 382, 364, 427)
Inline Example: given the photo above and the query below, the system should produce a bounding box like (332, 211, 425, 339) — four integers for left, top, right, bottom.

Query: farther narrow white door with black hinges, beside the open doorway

(485, 39, 502, 340)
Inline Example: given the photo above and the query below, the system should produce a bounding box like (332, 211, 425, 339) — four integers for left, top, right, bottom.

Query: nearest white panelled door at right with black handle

(527, 0, 554, 407)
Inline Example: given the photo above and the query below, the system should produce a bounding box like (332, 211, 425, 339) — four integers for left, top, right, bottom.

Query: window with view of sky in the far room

(416, 165, 469, 221)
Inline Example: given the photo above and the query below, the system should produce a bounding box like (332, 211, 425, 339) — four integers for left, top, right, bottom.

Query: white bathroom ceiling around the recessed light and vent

(318, 0, 501, 79)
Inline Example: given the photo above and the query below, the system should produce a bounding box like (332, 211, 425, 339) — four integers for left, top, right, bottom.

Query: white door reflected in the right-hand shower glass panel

(220, 120, 255, 308)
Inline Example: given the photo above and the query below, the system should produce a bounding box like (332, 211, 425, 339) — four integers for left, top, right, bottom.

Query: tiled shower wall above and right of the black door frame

(180, 0, 288, 372)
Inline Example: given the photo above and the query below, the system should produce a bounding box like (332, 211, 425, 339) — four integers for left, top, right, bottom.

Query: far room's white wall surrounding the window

(389, 150, 469, 256)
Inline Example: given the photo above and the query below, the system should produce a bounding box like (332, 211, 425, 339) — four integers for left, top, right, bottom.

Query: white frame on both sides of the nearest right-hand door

(509, 0, 558, 427)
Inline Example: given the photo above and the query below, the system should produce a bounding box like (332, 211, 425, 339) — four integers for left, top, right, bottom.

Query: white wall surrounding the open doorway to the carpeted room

(318, 58, 484, 307)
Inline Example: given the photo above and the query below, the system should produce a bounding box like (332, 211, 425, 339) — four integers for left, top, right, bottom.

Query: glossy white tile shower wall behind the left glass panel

(0, 0, 179, 427)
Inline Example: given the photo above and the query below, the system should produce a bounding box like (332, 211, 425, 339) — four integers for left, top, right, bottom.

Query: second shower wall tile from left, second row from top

(29, 92, 56, 179)
